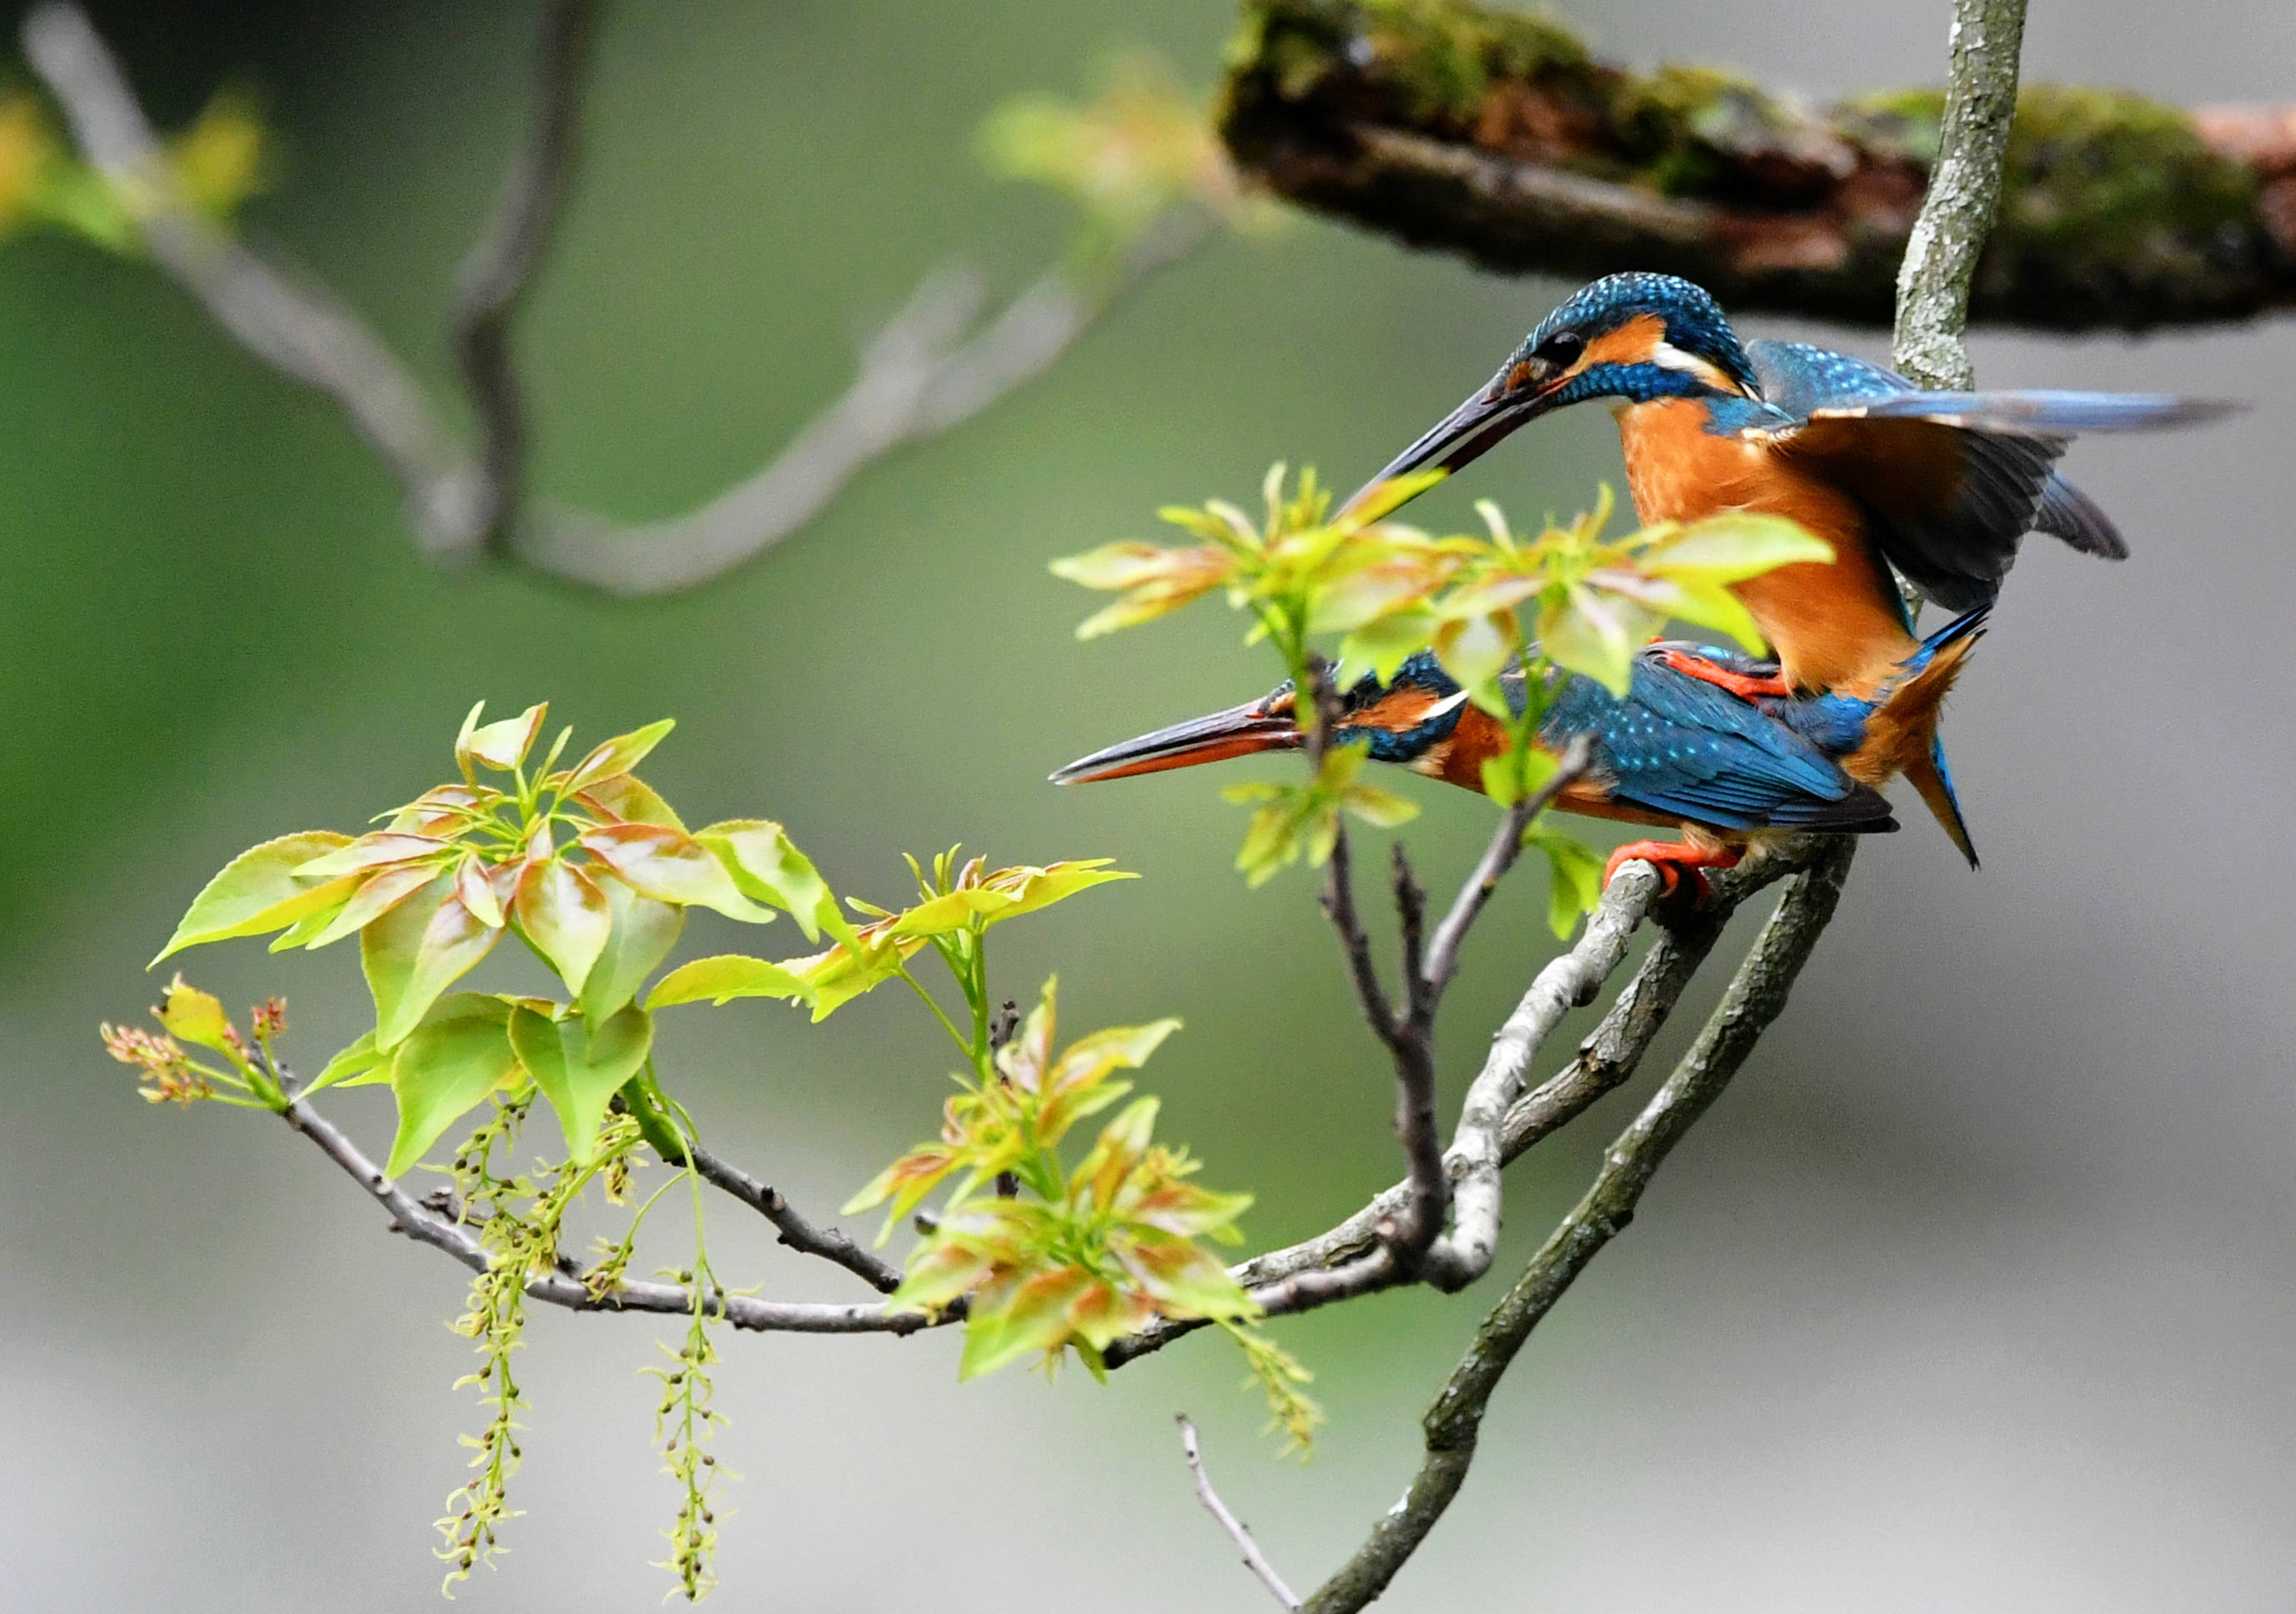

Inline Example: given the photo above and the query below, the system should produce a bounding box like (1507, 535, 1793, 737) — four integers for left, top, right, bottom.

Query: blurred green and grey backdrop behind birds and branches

(0, 0, 2296, 1612)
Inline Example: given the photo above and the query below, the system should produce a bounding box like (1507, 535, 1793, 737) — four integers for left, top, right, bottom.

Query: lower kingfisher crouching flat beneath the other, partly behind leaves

(1051, 606, 1989, 896)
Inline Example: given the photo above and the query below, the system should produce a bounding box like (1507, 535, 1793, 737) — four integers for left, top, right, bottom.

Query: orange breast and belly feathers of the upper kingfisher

(1619, 397, 1915, 696)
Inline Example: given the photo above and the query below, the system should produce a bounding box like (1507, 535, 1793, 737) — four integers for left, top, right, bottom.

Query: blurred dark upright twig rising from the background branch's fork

(455, 0, 606, 549)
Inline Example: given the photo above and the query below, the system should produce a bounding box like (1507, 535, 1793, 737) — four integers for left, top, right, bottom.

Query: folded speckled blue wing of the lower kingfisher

(1540, 645, 1896, 831)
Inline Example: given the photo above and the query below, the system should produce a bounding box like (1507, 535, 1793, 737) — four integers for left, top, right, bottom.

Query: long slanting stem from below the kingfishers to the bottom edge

(1304, 836, 1858, 1614)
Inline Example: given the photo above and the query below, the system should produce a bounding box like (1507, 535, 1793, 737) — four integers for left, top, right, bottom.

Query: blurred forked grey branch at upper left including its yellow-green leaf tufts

(23, 0, 1258, 595)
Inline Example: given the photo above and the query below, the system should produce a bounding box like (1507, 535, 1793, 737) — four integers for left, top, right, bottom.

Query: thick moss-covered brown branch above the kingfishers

(1221, 0, 2296, 331)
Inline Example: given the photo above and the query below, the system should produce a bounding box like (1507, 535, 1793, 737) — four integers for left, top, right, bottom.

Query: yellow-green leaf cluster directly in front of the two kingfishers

(1051, 464, 1832, 934)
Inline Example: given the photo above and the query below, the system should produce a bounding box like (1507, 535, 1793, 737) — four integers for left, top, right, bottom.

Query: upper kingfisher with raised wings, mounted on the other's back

(1350, 273, 2232, 863)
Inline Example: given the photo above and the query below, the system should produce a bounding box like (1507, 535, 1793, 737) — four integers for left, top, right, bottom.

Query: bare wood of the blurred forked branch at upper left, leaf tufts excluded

(23, 0, 1215, 595)
